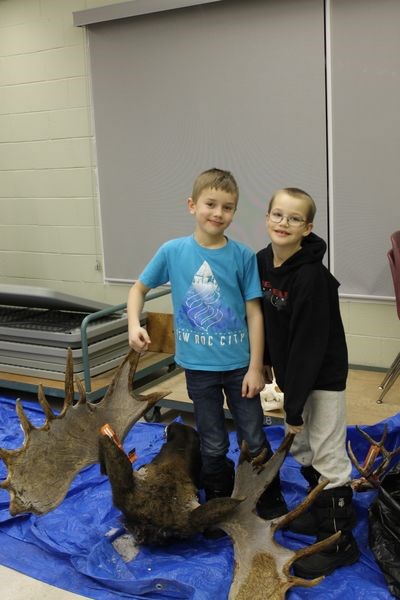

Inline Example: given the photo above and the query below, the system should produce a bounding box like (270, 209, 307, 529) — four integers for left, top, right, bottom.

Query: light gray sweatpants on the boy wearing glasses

(290, 390, 352, 489)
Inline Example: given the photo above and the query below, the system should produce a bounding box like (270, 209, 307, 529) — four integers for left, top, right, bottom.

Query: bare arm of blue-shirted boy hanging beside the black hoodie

(242, 298, 265, 398)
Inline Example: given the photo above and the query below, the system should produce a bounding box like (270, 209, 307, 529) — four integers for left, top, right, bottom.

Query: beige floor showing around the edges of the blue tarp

(0, 371, 400, 600)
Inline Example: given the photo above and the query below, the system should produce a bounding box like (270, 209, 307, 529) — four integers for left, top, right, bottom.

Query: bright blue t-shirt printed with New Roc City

(139, 236, 262, 371)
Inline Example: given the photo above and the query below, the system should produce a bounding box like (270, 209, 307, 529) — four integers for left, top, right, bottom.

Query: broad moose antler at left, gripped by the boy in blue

(0, 349, 168, 515)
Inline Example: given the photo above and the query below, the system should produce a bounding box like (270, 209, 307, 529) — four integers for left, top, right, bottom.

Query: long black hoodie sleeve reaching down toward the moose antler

(284, 265, 330, 425)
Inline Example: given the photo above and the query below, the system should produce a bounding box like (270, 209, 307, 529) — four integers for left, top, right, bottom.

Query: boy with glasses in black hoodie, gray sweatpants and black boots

(257, 188, 359, 577)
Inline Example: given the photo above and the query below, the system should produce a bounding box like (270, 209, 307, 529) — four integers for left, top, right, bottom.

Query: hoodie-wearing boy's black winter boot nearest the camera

(293, 486, 360, 579)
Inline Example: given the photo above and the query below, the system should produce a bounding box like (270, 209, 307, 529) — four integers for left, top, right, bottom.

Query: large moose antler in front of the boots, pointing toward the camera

(218, 434, 340, 600)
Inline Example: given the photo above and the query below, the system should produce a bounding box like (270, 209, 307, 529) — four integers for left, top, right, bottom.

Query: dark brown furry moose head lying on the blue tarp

(99, 423, 240, 545)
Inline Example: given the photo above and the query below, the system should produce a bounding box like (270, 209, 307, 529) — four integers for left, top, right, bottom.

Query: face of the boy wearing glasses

(267, 192, 313, 252)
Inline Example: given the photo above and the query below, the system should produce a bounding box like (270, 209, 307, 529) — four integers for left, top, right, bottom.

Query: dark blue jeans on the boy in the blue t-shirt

(185, 367, 272, 474)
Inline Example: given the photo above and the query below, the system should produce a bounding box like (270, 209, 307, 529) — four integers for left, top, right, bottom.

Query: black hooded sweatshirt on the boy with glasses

(257, 233, 348, 425)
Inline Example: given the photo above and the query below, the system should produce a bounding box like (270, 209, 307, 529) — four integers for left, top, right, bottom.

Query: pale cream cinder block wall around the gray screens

(0, 0, 400, 367)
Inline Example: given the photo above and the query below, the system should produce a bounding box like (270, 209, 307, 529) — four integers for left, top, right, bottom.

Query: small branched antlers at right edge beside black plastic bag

(348, 423, 400, 492)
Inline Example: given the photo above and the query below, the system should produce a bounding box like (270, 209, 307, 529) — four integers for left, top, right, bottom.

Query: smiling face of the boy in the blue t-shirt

(188, 188, 237, 239)
